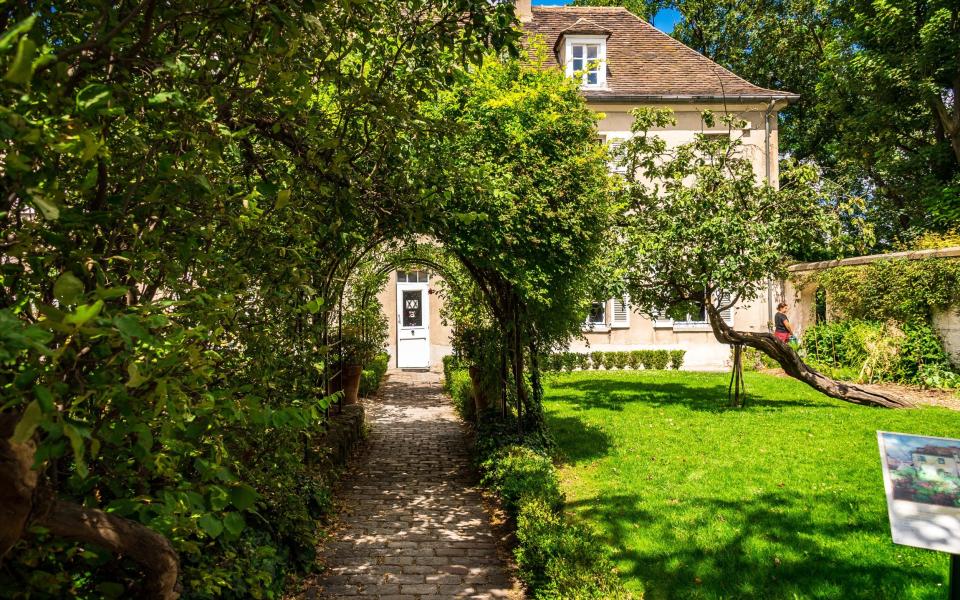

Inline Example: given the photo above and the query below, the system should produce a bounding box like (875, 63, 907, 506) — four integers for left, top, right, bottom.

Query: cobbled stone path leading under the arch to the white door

(308, 371, 522, 600)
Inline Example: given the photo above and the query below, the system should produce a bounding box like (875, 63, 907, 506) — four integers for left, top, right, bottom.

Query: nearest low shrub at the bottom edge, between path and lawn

(514, 498, 626, 600)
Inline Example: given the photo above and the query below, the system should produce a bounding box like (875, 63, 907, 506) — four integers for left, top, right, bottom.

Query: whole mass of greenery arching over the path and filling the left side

(0, 0, 608, 598)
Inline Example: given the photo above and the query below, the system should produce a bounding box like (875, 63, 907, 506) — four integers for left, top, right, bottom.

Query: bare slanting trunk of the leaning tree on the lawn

(707, 302, 912, 408)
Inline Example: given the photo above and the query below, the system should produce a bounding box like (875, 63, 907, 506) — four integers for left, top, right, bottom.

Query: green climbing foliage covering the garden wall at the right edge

(798, 258, 960, 323)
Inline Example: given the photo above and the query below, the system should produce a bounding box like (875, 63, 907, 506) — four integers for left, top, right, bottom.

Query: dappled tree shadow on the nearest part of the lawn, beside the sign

(568, 493, 946, 600)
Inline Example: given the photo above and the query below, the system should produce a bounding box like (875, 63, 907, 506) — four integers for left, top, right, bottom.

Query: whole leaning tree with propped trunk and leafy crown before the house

(618, 108, 905, 407)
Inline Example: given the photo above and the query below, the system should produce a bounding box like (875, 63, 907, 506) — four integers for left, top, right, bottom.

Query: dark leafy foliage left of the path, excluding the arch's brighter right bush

(0, 0, 517, 598)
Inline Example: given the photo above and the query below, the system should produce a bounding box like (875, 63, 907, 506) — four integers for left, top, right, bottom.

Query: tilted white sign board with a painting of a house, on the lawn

(877, 431, 960, 554)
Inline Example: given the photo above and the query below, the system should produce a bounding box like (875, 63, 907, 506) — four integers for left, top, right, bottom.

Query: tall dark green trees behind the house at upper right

(576, 0, 960, 248)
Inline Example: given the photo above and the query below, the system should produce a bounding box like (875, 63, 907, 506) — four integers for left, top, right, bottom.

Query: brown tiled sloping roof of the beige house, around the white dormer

(524, 6, 799, 102)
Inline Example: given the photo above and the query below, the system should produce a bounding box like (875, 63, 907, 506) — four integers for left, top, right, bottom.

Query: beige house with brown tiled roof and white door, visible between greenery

(379, 0, 797, 369)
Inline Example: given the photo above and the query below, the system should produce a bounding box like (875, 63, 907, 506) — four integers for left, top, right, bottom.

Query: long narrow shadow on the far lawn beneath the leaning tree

(547, 377, 836, 413)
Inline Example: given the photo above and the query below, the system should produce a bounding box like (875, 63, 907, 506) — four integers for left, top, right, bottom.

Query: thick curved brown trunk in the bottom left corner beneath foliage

(0, 414, 180, 600)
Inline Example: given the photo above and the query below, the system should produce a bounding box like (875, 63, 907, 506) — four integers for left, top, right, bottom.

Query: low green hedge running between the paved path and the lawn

(444, 368, 628, 600)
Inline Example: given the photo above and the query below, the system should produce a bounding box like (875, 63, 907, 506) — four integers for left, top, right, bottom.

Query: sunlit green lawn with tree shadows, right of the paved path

(546, 371, 960, 600)
